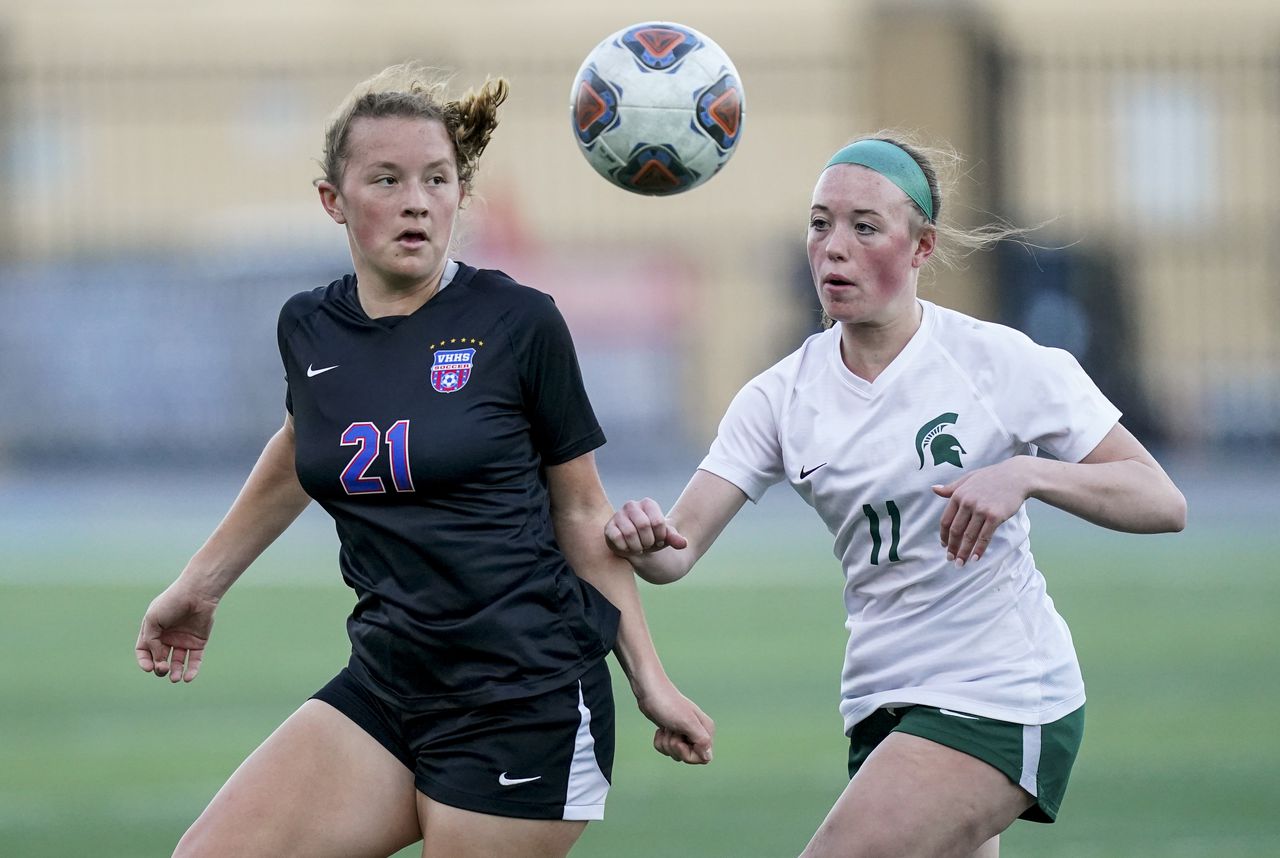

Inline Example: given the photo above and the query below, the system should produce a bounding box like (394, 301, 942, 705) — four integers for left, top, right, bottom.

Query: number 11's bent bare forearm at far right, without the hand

(1025, 425, 1187, 533)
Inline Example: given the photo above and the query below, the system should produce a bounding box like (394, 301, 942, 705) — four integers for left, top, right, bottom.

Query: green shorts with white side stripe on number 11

(849, 706, 1084, 822)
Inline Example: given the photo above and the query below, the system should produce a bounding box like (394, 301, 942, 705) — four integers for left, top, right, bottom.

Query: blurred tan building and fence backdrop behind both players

(0, 0, 1280, 464)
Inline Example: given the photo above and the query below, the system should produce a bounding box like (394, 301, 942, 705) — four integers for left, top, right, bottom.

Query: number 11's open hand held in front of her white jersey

(933, 456, 1029, 566)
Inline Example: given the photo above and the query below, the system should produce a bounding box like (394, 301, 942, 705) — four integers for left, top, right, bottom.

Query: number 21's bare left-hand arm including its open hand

(134, 415, 311, 683)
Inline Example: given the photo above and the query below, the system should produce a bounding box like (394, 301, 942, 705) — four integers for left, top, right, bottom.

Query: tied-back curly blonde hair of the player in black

(320, 63, 509, 195)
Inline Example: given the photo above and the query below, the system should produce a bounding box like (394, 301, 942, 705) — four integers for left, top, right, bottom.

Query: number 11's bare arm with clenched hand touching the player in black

(604, 470, 746, 584)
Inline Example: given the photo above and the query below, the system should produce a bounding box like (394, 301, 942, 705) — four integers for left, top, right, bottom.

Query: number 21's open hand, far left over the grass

(134, 579, 218, 683)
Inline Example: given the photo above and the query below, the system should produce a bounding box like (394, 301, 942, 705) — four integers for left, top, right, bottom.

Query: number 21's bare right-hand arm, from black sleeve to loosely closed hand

(547, 453, 716, 763)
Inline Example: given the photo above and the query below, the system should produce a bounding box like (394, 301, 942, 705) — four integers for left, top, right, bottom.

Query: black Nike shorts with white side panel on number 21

(312, 660, 613, 820)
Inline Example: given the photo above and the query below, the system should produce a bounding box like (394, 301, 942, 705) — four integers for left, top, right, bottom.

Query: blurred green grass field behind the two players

(0, 473, 1280, 858)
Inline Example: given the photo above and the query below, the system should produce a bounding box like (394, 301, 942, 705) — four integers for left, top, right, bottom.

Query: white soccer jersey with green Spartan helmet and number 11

(700, 301, 1120, 731)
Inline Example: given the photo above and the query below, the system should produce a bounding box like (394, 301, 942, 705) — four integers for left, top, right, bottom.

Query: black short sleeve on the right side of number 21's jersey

(520, 293, 604, 465)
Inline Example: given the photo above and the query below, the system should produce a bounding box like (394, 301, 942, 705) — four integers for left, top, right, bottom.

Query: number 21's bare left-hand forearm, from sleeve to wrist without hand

(180, 419, 311, 599)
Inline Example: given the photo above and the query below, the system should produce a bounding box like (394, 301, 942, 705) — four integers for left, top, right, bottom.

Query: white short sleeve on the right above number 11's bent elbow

(1000, 343, 1120, 462)
